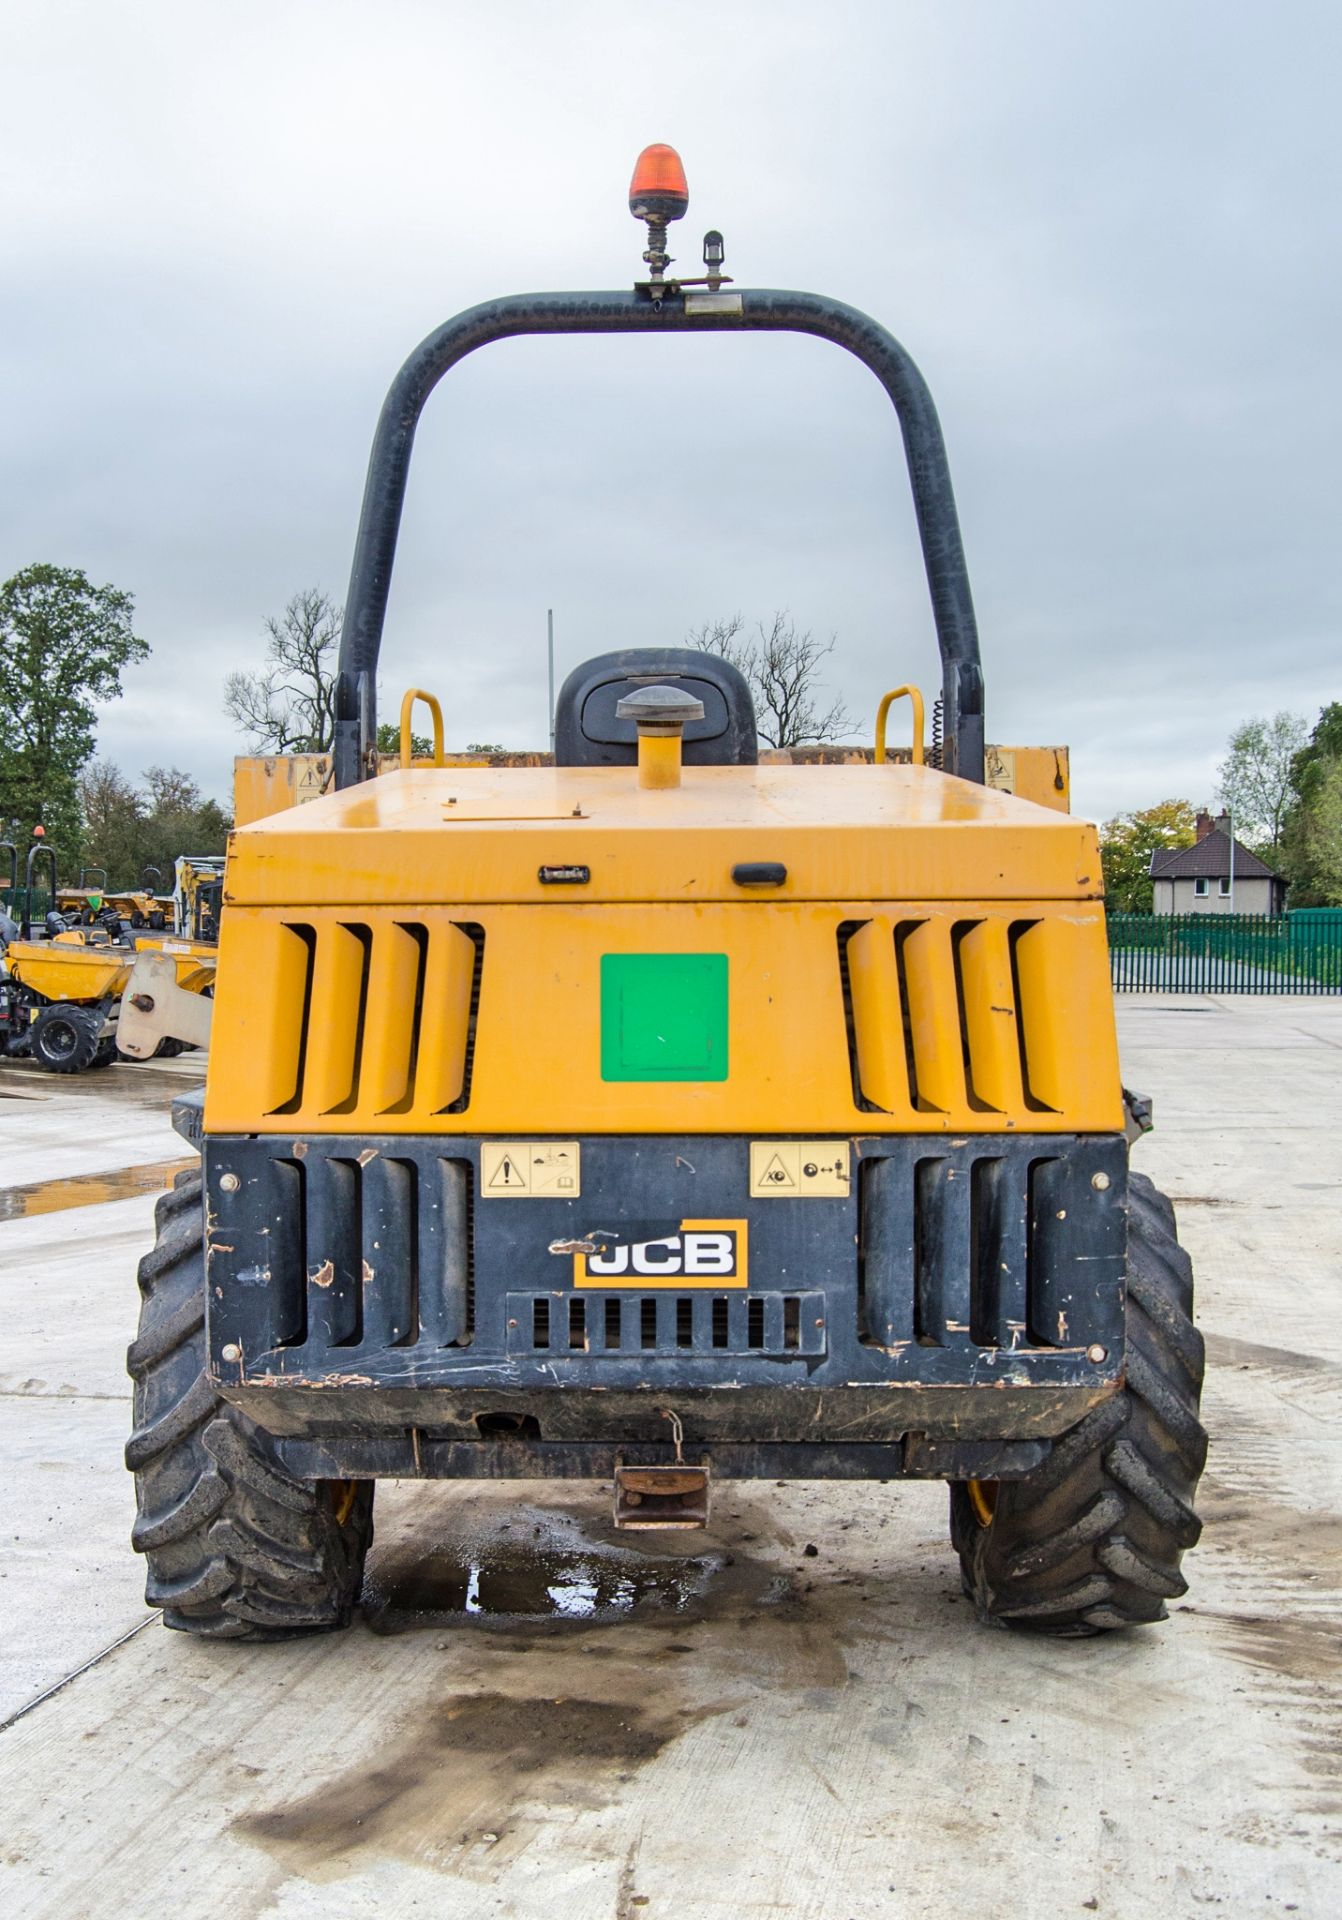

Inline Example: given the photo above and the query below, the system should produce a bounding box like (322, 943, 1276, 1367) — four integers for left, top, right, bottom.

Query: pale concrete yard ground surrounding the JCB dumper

(0, 996, 1342, 1920)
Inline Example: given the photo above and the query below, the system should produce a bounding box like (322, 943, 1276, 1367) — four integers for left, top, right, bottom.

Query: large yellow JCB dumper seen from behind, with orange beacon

(127, 148, 1206, 1638)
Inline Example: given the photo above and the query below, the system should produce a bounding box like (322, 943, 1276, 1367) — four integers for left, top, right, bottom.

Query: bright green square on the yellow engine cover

(601, 954, 728, 1081)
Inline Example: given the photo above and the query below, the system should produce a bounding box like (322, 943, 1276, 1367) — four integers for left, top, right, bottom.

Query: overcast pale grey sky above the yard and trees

(0, 0, 1342, 816)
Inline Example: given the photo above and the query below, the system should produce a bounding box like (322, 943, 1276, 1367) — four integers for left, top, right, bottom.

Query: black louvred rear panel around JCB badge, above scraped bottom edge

(204, 1135, 1127, 1438)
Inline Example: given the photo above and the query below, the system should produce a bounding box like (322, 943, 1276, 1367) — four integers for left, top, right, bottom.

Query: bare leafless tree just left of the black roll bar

(225, 588, 344, 753)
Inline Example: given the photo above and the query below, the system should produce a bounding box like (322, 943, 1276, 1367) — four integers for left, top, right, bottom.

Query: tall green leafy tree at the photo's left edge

(0, 564, 150, 864)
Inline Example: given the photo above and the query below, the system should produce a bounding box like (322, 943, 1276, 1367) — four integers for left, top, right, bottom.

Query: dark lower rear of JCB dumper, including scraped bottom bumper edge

(193, 1135, 1127, 1475)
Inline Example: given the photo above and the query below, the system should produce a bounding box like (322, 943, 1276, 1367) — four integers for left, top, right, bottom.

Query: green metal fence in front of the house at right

(1108, 908, 1342, 993)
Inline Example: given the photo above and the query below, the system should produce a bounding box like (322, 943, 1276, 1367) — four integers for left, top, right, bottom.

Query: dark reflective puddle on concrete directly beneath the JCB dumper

(363, 1507, 733, 1634)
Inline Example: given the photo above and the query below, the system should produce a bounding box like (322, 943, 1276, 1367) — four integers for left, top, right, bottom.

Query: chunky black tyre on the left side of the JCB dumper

(127, 1173, 372, 1640)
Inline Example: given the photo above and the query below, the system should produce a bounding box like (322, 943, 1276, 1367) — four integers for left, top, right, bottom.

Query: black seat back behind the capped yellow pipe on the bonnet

(555, 647, 760, 766)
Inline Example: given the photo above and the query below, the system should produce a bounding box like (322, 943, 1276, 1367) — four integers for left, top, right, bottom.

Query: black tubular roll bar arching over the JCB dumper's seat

(334, 290, 983, 787)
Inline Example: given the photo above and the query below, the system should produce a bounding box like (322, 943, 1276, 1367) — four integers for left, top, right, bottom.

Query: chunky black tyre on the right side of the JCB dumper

(950, 1173, 1208, 1634)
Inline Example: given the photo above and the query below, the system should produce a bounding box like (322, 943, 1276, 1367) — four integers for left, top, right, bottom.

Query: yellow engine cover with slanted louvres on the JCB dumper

(205, 764, 1123, 1139)
